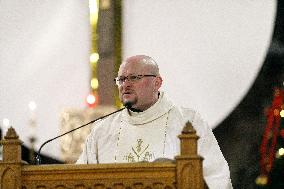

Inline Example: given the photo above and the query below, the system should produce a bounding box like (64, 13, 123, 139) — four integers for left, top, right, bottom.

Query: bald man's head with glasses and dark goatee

(117, 55, 163, 111)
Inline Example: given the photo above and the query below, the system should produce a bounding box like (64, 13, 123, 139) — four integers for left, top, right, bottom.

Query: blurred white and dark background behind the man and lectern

(0, 0, 284, 189)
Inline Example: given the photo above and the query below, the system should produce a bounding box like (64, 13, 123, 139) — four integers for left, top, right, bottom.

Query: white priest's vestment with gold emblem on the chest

(77, 92, 232, 189)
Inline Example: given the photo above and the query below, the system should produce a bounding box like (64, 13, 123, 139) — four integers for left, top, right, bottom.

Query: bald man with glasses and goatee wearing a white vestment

(77, 55, 232, 189)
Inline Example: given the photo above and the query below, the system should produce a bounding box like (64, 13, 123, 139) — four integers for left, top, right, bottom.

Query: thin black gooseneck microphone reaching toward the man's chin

(35, 108, 125, 165)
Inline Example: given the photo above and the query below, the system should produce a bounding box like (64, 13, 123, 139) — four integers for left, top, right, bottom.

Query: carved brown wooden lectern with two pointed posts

(0, 123, 205, 189)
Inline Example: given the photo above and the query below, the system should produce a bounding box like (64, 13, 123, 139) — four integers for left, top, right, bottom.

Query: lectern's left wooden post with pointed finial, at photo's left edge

(0, 127, 22, 189)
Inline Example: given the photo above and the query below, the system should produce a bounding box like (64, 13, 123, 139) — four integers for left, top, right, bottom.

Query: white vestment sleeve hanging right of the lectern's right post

(192, 113, 232, 189)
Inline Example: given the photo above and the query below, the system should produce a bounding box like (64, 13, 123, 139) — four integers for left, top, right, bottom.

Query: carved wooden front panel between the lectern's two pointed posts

(22, 163, 176, 189)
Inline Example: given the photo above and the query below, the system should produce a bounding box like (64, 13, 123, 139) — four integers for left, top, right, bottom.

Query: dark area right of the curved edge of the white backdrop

(213, 0, 284, 189)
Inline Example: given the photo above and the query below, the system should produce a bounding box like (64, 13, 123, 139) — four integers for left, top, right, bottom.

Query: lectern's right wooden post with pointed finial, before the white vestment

(175, 122, 204, 189)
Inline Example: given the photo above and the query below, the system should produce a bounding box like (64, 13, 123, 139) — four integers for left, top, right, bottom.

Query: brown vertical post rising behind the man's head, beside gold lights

(97, 0, 121, 106)
